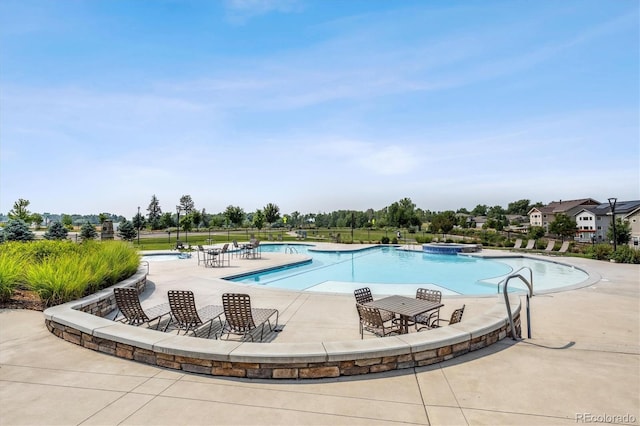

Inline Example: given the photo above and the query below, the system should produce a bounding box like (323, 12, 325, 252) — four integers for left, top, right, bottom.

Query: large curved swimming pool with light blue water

(227, 244, 588, 295)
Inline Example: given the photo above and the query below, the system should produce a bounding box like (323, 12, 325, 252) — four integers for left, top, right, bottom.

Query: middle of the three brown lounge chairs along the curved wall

(165, 290, 224, 337)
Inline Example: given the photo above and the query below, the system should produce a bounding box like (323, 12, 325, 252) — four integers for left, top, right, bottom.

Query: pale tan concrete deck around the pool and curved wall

(0, 246, 640, 425)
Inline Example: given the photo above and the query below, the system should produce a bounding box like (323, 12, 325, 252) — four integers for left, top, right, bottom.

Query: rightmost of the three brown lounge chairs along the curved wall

(220, 293, 279, 342)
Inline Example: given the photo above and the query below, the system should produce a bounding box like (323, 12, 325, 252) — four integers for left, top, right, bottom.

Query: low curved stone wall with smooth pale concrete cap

(45, 270, 521, 379)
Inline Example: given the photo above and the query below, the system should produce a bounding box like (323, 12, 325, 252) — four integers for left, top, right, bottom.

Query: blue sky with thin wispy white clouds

(0, 0, 640, 217)
